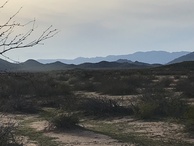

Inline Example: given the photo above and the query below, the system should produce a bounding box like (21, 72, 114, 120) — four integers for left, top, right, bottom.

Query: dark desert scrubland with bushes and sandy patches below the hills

(0, 64, 194, 146)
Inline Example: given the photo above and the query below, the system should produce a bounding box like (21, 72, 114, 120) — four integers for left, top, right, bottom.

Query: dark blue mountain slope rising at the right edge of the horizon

(168, 52, 194, 64)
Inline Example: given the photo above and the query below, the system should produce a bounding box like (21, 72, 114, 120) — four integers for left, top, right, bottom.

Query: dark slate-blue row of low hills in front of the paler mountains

(0, 59, 159, 72)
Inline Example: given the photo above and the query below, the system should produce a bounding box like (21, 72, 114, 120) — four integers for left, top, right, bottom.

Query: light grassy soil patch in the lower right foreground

(93, 117, 194, 144)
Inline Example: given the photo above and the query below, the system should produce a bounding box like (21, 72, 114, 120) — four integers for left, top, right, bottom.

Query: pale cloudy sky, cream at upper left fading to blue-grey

(0, 0, 194, 61)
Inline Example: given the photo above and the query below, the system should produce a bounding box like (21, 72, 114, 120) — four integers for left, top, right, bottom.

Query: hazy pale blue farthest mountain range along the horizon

(38, 51, 190, 64)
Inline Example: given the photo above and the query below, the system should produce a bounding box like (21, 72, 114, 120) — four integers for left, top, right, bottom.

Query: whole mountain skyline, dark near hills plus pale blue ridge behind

(0, 51, 194, 72)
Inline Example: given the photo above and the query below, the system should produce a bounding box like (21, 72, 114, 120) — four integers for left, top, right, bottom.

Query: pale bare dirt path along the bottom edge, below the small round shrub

(30, 121, 135, 146)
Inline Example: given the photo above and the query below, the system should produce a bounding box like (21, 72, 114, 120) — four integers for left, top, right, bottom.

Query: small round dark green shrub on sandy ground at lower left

(51, 114, 79, 129)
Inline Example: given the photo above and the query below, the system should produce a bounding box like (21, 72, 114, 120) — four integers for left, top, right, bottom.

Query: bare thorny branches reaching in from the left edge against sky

(0, 1, 58, 57)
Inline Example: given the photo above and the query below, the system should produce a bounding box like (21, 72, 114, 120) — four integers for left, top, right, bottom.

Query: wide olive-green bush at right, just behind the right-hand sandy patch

(135, 91, 188, 119)
